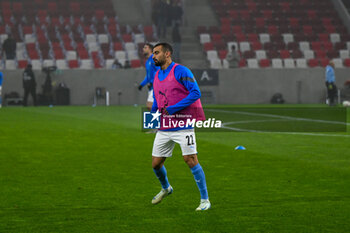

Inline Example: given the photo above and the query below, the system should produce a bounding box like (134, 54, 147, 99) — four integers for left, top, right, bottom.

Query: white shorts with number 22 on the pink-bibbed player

(152, 129, 197, 157)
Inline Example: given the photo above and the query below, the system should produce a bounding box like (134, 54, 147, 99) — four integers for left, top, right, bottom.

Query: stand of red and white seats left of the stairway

(0, 0, 158, 69)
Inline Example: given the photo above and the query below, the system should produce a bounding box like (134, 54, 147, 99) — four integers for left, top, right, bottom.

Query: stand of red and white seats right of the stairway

(197, 0, 350, 68)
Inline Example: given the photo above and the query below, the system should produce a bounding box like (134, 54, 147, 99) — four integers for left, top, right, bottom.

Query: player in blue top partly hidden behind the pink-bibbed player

(139, 43, 159, 109)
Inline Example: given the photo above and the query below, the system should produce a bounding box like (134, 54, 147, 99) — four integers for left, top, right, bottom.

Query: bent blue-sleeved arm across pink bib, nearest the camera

(166, 66, 201, 115)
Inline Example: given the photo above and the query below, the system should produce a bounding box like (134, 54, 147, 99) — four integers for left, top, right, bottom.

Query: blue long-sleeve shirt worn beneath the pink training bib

(152, 62, 201, 115)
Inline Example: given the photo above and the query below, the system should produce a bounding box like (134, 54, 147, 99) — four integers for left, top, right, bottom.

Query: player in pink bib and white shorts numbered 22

(152, 43, 211, 211)
